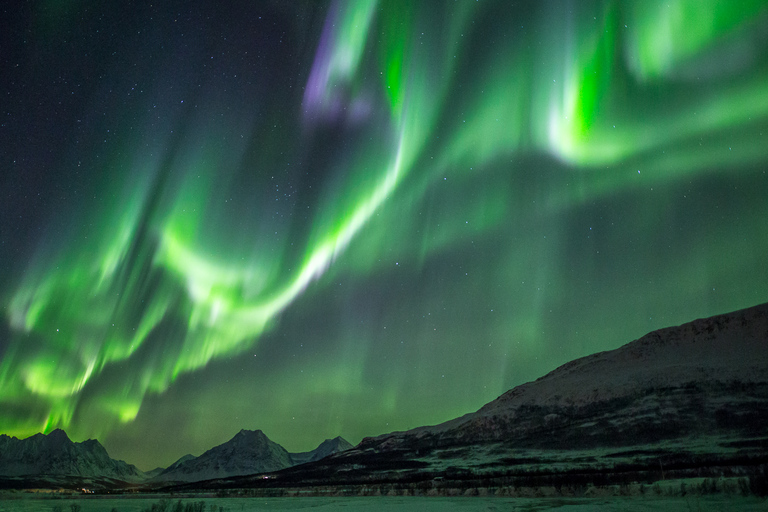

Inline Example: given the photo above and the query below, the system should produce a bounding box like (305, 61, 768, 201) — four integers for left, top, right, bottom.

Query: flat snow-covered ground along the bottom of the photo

(0, 495, 768, 512)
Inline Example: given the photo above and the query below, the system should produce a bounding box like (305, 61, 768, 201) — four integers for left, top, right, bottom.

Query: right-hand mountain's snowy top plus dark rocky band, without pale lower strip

(361, 304, 768, 449)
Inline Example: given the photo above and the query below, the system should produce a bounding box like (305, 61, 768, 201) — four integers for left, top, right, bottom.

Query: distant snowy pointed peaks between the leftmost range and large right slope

(152, 430, 352, 482)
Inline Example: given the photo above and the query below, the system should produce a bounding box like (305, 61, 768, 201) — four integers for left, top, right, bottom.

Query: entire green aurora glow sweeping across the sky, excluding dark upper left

(0, 0, 768, 470)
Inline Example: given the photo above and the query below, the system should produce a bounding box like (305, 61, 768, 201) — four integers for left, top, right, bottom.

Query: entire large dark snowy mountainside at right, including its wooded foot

(218, 303, 768, 488)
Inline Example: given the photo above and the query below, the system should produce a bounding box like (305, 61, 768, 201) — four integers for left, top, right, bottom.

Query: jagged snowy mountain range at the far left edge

(0, 429, 144, 482)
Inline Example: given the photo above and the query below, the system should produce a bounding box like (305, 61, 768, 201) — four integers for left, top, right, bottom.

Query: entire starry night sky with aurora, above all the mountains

(0, 0, 768, 470)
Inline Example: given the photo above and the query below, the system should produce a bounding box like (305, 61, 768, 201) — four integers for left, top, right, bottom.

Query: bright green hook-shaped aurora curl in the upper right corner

(539, 1, 768, 168)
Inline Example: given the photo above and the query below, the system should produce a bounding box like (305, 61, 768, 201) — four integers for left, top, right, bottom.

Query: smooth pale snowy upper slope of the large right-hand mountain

(363, 303, 768, 443)
